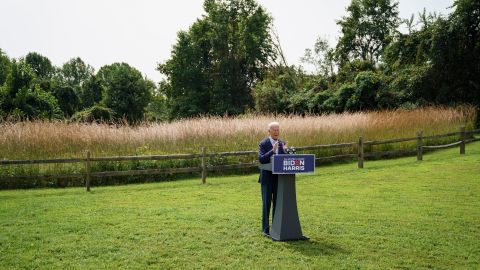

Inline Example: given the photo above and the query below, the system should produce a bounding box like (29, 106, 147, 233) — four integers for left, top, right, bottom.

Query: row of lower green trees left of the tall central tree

(0, 54, 155, 123)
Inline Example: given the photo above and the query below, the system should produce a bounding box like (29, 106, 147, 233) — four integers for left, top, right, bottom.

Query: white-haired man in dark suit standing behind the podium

(258, 122, 288, 236)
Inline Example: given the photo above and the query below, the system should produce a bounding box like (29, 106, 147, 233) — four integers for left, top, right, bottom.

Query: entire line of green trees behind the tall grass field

(0, 0, 480, 122)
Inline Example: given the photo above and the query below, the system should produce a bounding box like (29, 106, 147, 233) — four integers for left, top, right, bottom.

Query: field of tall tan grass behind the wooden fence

(0, 107, 476, 188)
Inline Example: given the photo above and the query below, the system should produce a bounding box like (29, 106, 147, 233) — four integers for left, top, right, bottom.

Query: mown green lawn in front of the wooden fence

(0, 143, 480, 269)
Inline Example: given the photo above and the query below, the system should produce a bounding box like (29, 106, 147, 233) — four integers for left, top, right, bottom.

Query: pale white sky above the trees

(0, 0, 453, 82)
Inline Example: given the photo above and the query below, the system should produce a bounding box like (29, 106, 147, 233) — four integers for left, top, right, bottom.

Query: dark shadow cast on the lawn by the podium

(285, 239, 350, 257)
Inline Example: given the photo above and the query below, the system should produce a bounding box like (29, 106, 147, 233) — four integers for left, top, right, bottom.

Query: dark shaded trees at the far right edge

(383, 0, 480, 110)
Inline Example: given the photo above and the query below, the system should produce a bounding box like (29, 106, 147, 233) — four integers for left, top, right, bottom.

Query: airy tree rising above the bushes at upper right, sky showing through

(336, 0, 399, 63)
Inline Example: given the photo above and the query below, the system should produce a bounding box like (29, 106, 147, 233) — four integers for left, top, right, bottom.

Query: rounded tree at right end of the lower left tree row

(97, 63, 152, 123)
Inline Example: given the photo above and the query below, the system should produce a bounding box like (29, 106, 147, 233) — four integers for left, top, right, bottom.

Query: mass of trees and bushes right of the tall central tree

(253, 0, 480, 116)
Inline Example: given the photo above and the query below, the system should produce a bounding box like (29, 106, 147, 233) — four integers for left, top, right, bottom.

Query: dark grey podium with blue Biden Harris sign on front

(259, 154, 315, 241)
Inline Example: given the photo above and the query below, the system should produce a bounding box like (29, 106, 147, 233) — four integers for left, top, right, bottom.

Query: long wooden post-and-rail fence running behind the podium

(0, 127, 480, 191)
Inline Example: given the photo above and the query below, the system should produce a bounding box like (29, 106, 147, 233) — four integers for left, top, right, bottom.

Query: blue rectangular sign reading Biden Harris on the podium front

(272, 155, 315, 174)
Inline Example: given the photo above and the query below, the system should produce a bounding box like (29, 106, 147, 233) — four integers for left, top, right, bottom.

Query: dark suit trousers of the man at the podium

(261, 174, 278, 233)
